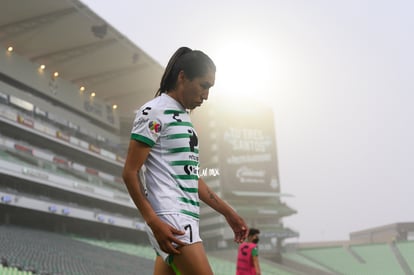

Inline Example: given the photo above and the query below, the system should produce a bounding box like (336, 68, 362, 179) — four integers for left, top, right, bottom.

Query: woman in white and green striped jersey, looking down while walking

(123, 47, 248, 275)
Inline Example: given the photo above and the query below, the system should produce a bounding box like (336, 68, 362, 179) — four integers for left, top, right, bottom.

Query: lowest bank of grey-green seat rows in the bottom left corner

(0, 225, 153, 275)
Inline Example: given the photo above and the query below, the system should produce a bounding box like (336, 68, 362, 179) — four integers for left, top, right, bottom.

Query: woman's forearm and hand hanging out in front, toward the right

(198, 178, 248, 243)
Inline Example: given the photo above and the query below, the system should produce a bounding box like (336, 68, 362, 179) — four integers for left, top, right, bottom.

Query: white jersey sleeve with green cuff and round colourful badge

(131, 105, 162, 147)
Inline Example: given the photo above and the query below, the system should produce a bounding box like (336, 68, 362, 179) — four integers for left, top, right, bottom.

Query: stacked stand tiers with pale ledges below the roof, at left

(0, 51, 150, 242)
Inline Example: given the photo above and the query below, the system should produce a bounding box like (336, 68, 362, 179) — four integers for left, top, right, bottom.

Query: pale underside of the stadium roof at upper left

(0, 0, 163, 119)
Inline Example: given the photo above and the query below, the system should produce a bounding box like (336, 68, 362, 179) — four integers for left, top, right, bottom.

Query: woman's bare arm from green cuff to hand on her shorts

(122, 139, 185, 254)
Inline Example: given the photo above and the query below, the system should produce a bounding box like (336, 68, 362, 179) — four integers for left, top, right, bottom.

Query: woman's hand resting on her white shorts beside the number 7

(148, 219, 186, 254)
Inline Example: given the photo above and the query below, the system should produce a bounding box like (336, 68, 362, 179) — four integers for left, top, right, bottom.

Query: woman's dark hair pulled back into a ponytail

(155, 47, 216, 96)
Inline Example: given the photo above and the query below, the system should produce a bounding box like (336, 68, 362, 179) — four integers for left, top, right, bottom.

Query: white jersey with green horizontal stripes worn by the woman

(131, 94, 200, 219)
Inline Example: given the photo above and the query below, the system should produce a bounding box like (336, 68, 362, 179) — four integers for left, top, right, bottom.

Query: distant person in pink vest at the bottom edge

(236, 228, 261, 275)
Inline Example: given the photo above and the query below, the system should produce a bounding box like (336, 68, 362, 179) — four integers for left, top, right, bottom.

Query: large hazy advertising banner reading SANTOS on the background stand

(217, 106, 279, 194)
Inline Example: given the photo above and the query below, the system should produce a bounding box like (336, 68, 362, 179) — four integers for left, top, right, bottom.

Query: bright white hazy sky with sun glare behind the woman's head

(82, 0, 414, 242)
